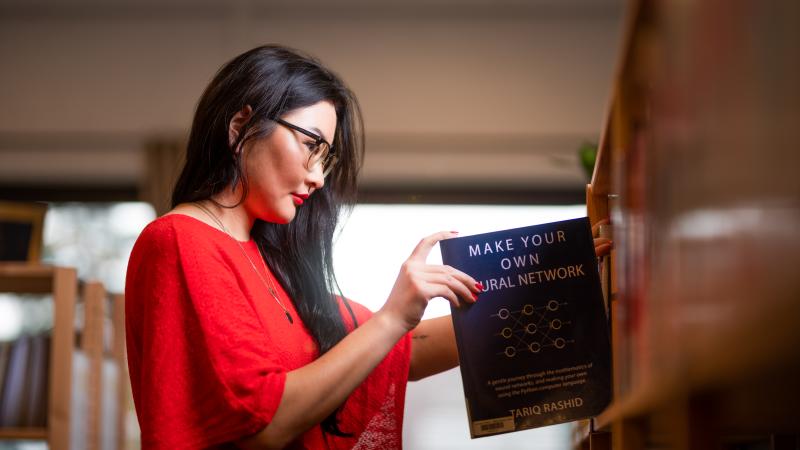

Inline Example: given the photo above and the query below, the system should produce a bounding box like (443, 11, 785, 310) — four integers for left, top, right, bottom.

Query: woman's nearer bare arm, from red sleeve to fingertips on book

(238, 232, 477, 448)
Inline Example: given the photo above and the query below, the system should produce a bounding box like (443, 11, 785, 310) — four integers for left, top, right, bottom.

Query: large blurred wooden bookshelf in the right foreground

(574, 0, 800, 450)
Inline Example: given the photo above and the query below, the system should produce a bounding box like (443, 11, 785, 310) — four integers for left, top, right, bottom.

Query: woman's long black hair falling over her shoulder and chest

(172, 45, 364, 436)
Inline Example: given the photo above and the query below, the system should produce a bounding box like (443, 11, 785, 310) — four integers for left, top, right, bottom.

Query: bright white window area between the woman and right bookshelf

(334, 204, 586, 450)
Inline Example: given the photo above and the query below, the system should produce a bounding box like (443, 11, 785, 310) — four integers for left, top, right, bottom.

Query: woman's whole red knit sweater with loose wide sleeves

(125, 214, 411, 449)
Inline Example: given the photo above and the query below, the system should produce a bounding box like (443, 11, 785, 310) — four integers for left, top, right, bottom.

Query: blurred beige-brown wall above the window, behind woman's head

(0, 0, 622, 199)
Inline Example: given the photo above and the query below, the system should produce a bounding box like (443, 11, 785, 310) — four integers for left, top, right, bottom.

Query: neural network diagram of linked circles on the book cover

(491, 300, 575, 358)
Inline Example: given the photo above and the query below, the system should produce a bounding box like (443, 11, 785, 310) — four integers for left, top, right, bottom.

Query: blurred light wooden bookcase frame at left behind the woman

(0, 263, 128, 450)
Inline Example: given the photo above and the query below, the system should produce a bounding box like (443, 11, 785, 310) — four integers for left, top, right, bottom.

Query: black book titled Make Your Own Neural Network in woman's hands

(440, 218, 611, 438)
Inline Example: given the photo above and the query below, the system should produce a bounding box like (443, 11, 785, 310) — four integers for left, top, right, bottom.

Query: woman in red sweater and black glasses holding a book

(126, 46, 481, 449)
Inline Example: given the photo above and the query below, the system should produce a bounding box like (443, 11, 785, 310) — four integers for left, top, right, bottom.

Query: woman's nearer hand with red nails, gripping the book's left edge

(377, 231, 482, 331)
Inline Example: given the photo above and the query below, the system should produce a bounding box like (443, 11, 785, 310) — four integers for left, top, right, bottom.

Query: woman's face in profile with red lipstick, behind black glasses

(243, 101, 336, 223)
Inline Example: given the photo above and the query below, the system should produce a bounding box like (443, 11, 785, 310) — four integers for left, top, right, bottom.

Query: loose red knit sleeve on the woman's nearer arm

(126, 222, 287, 449)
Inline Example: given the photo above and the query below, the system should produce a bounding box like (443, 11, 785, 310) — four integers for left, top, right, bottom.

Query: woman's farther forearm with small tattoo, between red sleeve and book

(408, 316, 458, 381)
